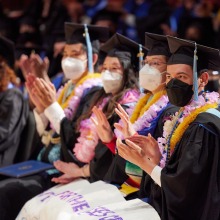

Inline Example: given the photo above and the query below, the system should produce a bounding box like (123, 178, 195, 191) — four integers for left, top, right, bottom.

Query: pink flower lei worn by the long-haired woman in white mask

(73, 90, 139, 163)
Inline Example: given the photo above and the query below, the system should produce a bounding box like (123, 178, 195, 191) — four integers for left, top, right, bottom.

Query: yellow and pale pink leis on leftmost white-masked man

(57, 73, 102, 120)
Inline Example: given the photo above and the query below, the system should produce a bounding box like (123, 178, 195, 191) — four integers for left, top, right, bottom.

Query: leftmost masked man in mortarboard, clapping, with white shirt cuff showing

(0, 23, 108, 219)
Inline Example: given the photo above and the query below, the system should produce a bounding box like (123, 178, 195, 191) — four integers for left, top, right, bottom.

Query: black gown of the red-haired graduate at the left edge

(0, 89, 29, 167)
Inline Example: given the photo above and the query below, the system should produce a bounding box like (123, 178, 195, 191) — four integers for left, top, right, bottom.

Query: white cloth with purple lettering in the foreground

(16, 179, 160, 220)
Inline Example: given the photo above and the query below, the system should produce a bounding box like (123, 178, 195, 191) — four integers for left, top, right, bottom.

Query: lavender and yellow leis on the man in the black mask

(158, 92, 219, 168)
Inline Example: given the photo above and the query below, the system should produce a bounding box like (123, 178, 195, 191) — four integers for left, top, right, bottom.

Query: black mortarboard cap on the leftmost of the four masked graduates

(65, 22, 109, 53)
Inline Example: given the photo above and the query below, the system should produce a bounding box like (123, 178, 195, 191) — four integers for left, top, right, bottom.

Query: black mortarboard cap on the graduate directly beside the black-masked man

(145, 32, 171, 57)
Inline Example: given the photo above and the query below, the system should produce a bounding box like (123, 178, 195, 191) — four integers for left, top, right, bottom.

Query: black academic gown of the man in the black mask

(161, 113, 220, 220)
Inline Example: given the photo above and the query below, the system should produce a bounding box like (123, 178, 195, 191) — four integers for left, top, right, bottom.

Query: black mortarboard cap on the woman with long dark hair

(100, 33, 147, 70)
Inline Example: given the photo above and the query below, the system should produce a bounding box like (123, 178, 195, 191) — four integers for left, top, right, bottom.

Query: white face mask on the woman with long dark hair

(102, 70, 122, 93)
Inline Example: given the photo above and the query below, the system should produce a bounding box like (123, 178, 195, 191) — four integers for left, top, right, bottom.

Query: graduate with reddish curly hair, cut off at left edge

(0, 37, 29, 167)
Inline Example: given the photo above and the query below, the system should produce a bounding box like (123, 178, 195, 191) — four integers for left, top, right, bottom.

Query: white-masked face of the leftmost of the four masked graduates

(62, 43, 87, 81)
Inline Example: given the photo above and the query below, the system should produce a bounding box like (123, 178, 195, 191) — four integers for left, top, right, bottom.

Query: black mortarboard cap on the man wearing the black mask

(167, 36, 220, 73)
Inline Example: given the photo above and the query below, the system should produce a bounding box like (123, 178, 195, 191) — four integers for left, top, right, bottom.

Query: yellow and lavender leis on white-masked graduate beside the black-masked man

(115, 90, 169, 139)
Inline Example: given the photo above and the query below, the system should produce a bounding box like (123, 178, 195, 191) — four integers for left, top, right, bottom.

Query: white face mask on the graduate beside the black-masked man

(139, 64, 165, 92)
